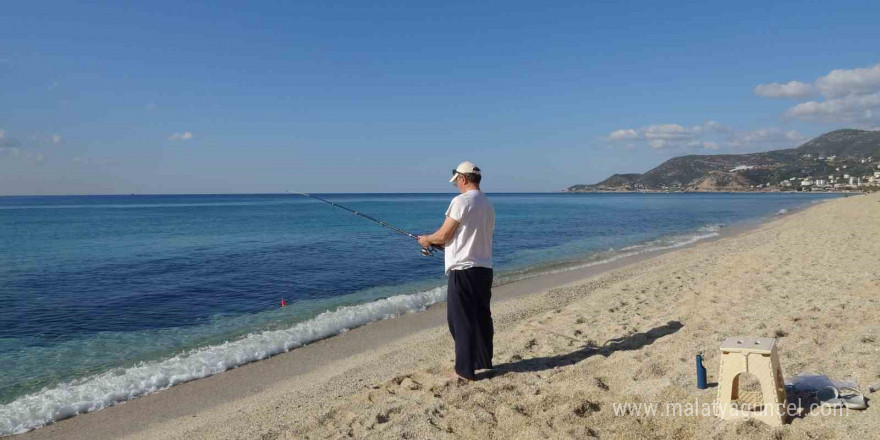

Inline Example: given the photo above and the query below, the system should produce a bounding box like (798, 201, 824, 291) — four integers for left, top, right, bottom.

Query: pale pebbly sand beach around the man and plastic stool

(15, 194, 880, 440)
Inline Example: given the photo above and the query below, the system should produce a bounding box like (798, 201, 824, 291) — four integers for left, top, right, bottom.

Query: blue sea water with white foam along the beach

(0, 194, 835, 435)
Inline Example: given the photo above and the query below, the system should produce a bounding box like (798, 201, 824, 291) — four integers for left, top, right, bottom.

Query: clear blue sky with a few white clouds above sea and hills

(0, 1, 880, 194)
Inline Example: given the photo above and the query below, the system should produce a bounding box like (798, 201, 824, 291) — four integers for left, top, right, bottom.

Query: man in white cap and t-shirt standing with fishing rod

(418, 162, 495, 380)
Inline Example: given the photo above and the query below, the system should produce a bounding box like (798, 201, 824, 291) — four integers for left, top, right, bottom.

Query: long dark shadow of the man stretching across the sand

(492, 321, 684, 376)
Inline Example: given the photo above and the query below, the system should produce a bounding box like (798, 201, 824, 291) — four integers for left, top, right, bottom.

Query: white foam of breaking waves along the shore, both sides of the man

(0, 194, 792, 429)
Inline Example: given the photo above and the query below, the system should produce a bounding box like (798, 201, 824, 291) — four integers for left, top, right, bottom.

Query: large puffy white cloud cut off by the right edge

(755, 64, 880, 127)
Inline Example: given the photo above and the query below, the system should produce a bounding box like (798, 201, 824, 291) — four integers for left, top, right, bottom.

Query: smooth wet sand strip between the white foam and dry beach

(13, 196, 836, 438)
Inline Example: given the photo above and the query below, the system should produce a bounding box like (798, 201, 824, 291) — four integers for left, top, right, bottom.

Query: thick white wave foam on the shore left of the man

(0, 287, 446, 436)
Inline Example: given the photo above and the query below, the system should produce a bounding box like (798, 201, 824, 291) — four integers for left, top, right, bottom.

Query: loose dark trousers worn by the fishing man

(446, 267, 495, 379)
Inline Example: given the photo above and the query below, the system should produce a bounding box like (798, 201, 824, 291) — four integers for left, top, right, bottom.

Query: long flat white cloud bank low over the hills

(605, 121, 805, 150)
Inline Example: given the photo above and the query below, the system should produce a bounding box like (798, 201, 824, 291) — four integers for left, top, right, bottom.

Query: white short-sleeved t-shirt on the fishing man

(443, 189, 495, 274)
